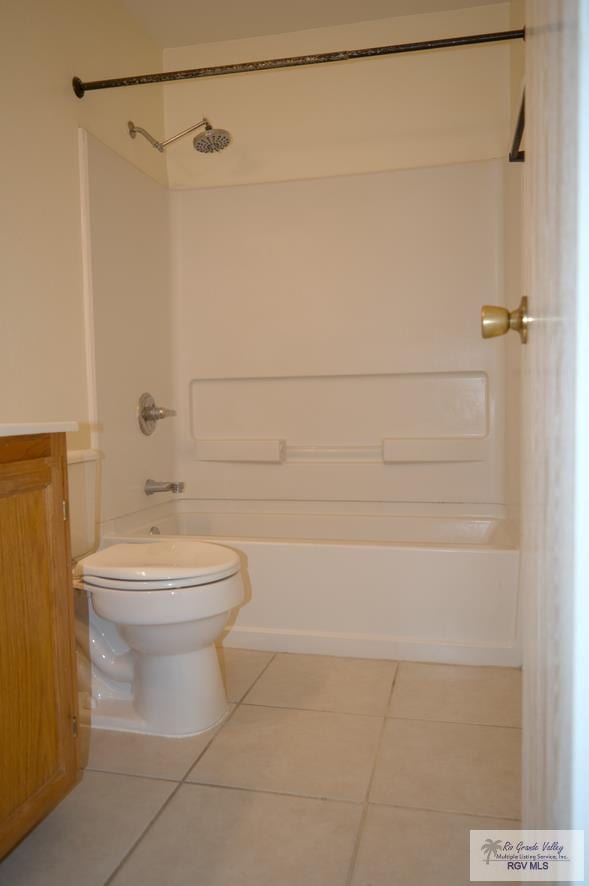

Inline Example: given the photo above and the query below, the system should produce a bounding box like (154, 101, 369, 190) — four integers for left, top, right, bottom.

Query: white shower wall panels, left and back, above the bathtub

(88, 137, 519, 521)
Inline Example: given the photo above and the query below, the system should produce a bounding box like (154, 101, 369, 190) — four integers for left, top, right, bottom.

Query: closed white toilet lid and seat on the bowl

(75, 539, 240, 590)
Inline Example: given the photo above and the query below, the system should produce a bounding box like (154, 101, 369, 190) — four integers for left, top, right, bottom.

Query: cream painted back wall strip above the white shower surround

(163, 3, 519, 188)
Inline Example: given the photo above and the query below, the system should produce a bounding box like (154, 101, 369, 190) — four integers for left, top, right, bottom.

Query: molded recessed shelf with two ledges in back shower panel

(192, 371, 493, 465)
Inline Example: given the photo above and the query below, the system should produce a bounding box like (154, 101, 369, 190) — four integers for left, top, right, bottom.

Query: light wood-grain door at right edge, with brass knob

(522, 0, 589, 832)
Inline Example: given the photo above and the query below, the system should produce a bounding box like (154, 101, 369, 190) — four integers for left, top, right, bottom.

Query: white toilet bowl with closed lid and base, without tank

(74, 539, 244, 736)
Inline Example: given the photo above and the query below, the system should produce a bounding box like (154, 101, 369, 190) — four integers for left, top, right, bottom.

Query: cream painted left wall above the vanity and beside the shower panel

(0, 0, 165, 447)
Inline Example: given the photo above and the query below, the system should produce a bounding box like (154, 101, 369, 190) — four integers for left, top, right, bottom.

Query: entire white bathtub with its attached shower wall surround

(81, 139, 519, 665)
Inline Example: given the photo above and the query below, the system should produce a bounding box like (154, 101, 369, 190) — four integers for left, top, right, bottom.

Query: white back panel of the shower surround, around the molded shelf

(172, 161, 515, 504)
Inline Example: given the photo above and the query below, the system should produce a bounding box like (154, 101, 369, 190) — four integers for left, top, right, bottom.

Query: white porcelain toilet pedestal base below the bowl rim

(76, 599, 237, 738)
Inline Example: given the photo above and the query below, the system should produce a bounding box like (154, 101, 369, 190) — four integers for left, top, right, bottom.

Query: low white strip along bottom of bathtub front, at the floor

(223, 626, 521, 667)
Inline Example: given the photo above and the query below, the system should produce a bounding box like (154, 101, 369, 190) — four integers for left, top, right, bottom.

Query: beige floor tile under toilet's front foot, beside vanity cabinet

(80, 712, 230, 781)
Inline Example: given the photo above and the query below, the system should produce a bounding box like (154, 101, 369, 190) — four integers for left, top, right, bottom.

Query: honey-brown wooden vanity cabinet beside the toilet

(0, 433, 78, 858)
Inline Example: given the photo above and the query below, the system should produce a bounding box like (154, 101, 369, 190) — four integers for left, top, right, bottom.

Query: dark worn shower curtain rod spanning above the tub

(72, 28, 526, 98)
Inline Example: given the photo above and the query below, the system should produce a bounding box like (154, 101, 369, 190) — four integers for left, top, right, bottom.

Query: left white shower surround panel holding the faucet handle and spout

(86, 136, 175, 521)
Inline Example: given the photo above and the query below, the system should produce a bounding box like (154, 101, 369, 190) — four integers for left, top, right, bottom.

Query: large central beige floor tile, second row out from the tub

(188, 705, 382, 800)
